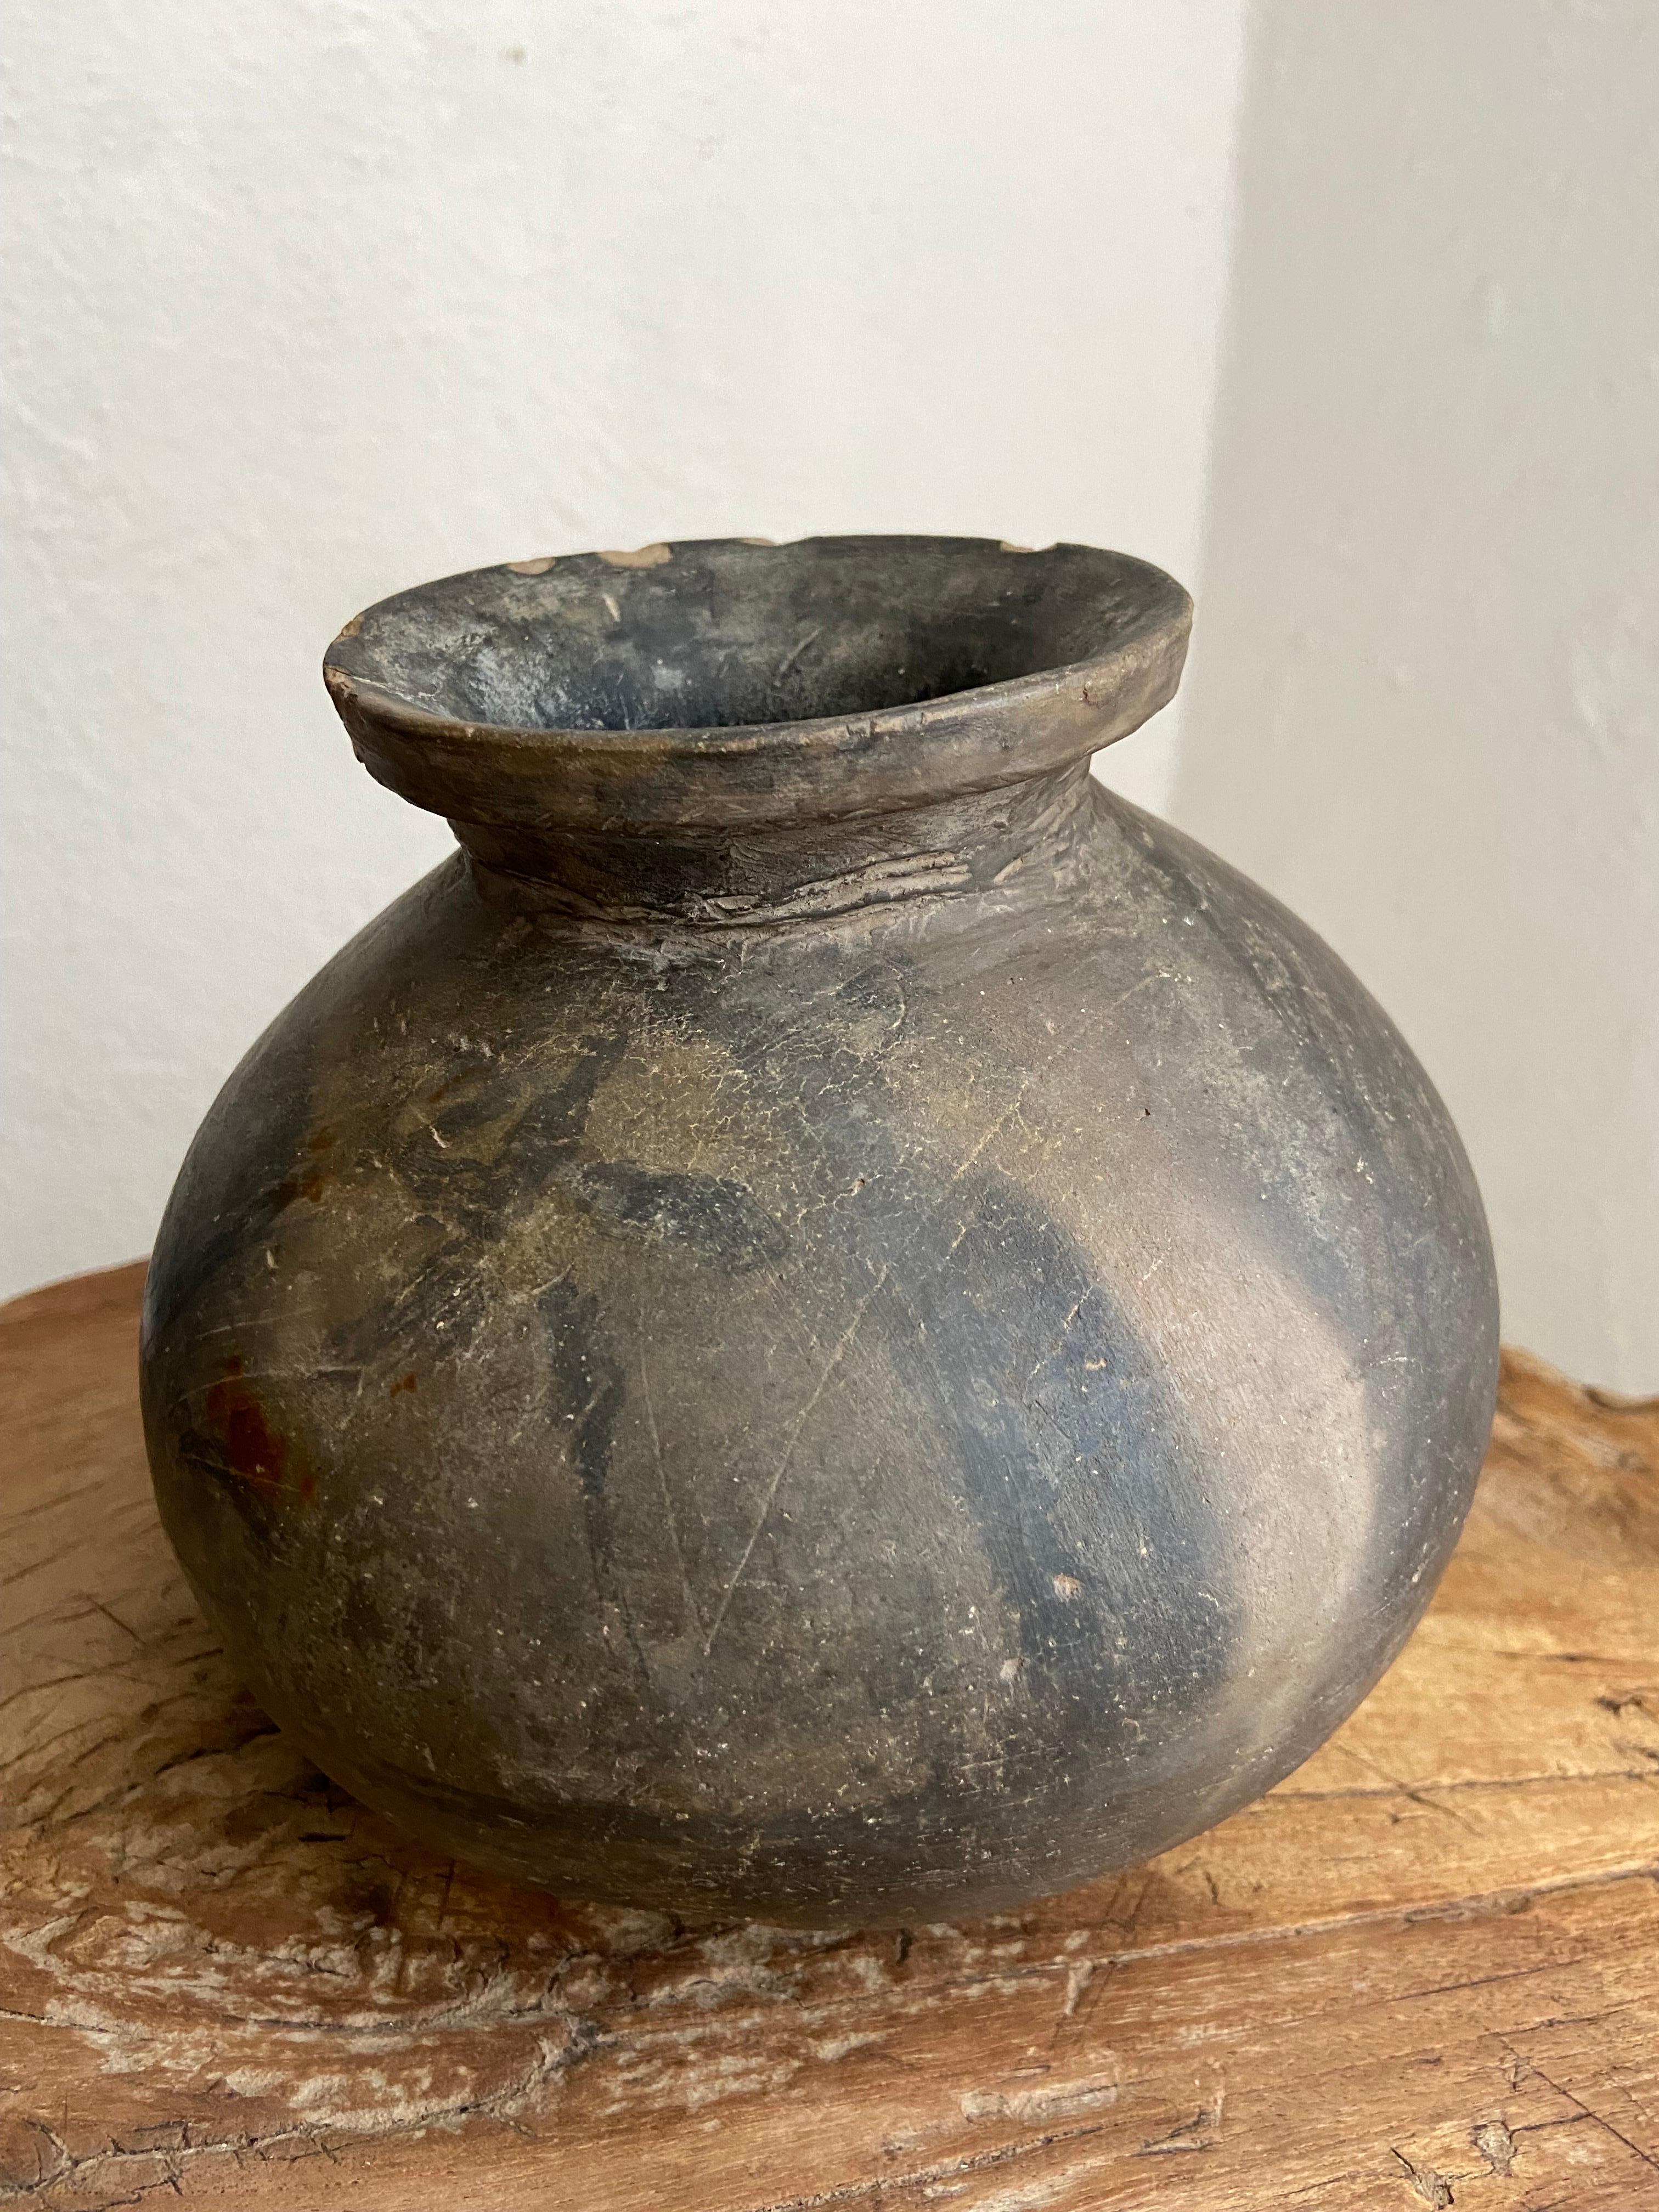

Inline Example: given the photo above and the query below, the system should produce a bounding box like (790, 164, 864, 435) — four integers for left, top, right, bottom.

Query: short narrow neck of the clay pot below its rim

(449, 761, 1093, 931)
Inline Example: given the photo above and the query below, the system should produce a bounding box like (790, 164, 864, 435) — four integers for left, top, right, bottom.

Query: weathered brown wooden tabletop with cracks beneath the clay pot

(0, 1267, 1659, 2212)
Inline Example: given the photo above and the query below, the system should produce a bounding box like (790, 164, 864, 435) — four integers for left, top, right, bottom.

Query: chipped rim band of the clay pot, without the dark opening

(323, 535, 1192, 834)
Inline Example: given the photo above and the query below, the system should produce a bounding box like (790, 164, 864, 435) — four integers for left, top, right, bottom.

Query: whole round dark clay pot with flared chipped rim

(144, 538, 1498, 1925)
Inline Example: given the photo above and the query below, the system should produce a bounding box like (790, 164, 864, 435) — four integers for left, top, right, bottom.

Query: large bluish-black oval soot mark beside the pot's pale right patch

(884, 1170, 1232, 1707)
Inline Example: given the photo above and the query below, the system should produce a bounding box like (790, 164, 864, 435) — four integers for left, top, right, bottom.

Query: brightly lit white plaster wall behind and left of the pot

(0, 0, 1241, 1292)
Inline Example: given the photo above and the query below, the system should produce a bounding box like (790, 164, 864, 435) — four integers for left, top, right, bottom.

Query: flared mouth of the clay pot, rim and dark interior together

(323, 538, 1192, 832)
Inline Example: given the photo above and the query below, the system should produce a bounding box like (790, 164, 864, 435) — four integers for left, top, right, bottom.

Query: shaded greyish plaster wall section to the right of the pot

(1175, 0, 1659, 1389)
